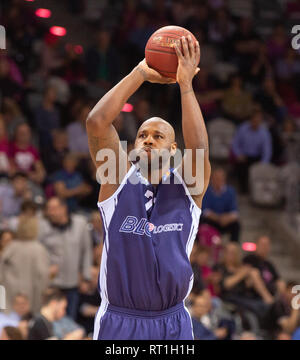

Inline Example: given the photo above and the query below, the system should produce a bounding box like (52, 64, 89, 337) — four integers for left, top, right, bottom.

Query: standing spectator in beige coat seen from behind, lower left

(0, 207, 49, 312)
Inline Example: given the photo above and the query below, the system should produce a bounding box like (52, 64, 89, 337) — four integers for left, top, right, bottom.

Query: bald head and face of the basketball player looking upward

(135, 121, 176, 167)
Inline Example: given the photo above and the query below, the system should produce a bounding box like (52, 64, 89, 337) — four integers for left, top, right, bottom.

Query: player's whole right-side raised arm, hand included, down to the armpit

(175, 36, 211, 207)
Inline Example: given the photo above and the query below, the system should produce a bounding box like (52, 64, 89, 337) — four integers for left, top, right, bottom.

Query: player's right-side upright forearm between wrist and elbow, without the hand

(180, 83, 208, 155)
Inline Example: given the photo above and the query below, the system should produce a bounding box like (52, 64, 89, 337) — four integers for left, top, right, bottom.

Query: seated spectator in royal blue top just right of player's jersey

(201, 169, 240, 241)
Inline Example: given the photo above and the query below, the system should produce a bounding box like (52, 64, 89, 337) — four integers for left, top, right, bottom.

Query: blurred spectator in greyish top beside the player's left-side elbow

(67, 104, 91, 159)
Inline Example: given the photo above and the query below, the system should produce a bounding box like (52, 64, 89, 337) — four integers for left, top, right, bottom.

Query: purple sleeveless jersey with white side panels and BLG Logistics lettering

(95, 165, 201, 333)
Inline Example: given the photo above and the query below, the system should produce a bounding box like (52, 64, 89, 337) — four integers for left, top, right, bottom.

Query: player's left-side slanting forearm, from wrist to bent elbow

(87, 66, 144, 126)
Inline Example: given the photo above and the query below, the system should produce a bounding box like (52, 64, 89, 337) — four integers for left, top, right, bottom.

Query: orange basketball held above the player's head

(145, 25, 197, 79)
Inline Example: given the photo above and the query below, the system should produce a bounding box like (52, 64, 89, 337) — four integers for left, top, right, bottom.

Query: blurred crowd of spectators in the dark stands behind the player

(0, 0, 300, 339)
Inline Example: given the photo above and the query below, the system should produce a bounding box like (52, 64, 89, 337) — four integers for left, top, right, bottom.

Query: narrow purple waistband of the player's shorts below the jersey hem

(107, 302, 184, 318)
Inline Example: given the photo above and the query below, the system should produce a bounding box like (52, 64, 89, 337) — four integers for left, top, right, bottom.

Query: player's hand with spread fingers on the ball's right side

(174, 35, 200, 85)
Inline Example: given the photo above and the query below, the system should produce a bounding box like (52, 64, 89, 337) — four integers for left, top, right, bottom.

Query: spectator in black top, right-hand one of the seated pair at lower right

(243, 236, 285, 296)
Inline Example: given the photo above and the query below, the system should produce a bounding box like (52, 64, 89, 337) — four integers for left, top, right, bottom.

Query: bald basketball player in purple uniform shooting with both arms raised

(87, 37, 210, 340)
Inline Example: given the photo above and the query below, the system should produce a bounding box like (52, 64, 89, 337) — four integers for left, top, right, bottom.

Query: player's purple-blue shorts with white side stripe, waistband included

(94, 303, 194, 340)
